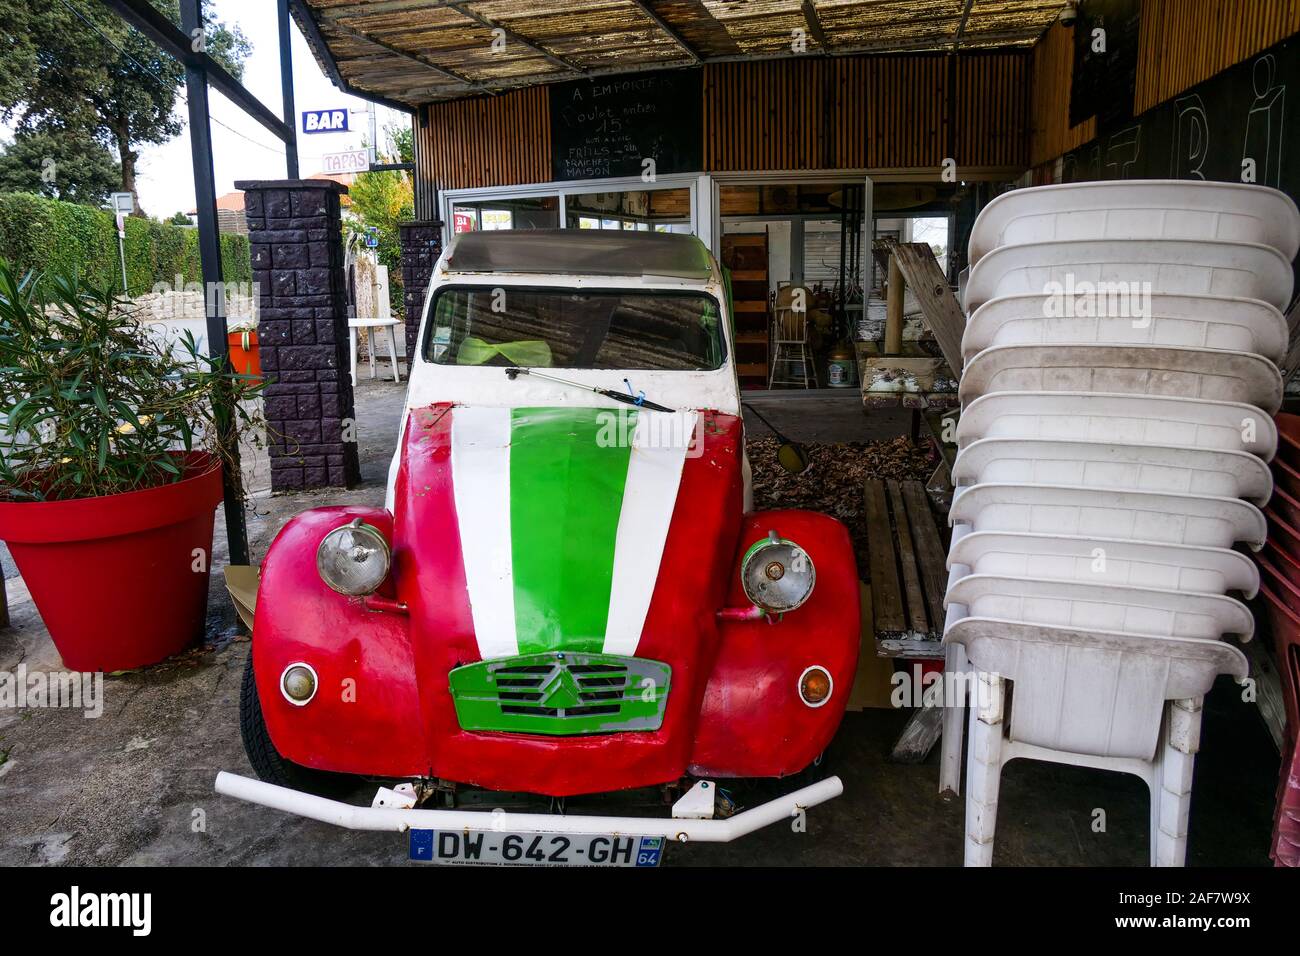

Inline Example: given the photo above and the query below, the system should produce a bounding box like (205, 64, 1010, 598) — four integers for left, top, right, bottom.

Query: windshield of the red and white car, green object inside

(424, 286, 725, 372)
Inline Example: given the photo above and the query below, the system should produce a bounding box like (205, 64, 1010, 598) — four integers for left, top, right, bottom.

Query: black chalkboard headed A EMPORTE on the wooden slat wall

(550, 69, 703, 179)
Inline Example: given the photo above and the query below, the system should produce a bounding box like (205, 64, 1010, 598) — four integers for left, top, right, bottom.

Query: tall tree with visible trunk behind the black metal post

(0, 0, 252, 209)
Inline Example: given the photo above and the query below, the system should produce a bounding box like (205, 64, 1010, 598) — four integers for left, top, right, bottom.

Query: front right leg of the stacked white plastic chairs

(1151, 697, 1201, 866)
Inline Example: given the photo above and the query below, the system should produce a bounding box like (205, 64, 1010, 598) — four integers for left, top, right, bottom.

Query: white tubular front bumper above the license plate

(216, 771, 844, 843)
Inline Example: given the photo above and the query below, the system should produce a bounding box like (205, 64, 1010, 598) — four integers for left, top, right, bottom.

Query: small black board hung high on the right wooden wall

(1070, 0, 1141, 126)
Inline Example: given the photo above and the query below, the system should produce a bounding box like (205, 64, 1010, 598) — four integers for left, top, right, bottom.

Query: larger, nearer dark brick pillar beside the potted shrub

(235, 179, 361, 492)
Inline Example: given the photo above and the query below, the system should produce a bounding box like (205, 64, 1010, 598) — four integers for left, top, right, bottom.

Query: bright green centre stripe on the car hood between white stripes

(510, 408, 636, 654)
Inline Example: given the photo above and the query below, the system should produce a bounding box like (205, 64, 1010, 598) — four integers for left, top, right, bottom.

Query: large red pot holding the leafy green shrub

(0, 453, 221, 671)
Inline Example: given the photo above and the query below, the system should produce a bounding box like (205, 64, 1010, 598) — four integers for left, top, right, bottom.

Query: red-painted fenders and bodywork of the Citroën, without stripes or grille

(252, 403, 859, 796)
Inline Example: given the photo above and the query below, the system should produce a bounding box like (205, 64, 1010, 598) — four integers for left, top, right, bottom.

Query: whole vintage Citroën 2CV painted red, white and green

(217, 230, 859, 864)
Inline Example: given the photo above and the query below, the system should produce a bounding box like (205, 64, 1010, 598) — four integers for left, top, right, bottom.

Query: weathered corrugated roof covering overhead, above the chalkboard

(293, 0, 1065, 107)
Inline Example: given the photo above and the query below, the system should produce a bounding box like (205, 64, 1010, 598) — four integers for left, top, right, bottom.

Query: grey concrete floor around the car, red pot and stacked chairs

(0, 371, 1278, 866)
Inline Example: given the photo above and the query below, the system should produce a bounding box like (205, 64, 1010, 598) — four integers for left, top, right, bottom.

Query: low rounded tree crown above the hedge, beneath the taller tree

(0, 130, 120, 206)
